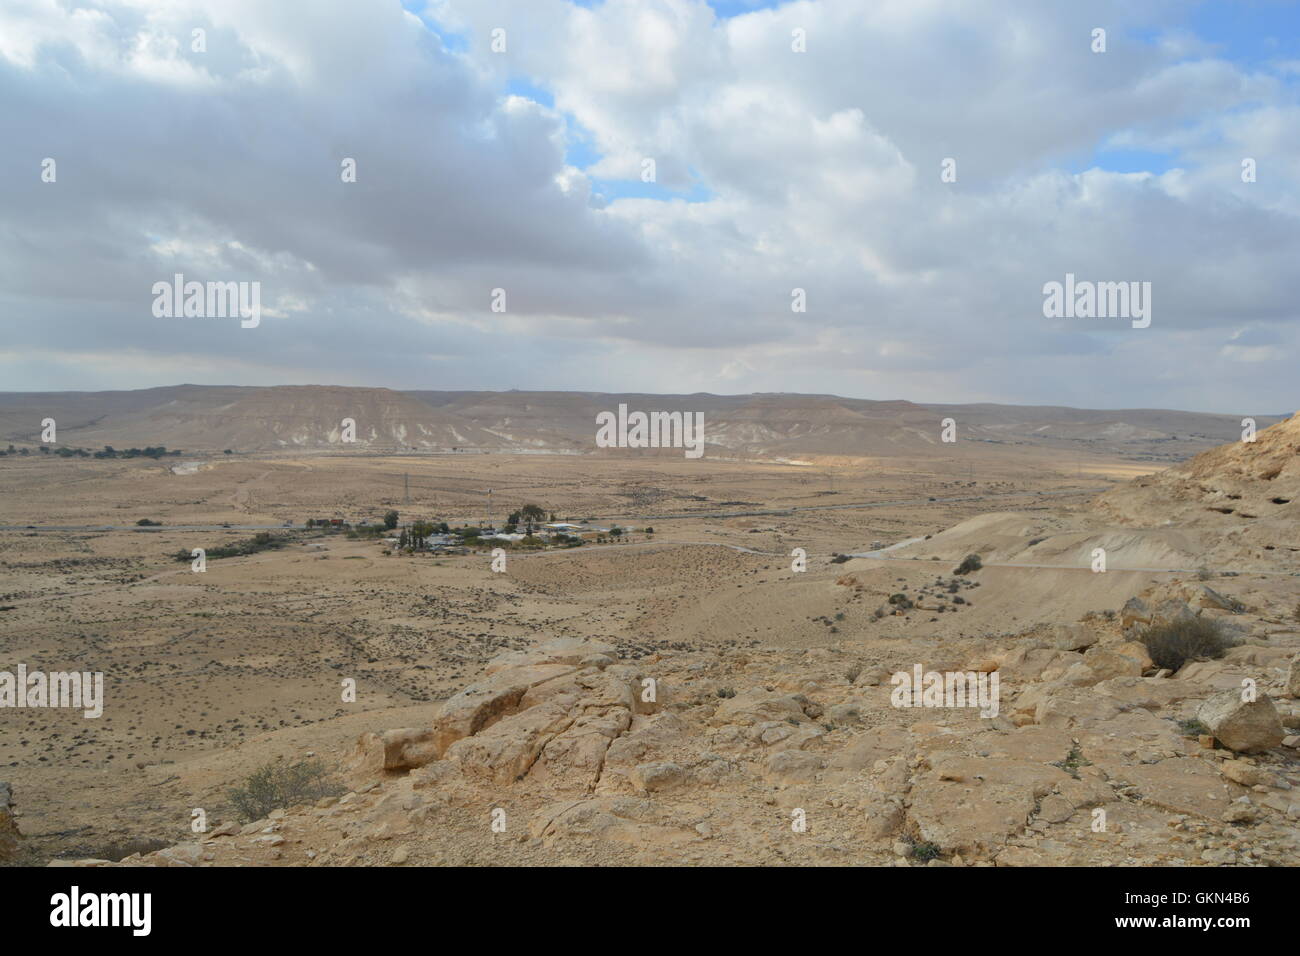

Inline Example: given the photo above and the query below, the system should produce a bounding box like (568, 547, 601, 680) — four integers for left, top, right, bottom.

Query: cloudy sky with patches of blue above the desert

(0, 0, 1300, 414)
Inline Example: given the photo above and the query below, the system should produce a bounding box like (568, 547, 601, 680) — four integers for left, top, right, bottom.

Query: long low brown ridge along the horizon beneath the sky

(0, 385, 1284, 460)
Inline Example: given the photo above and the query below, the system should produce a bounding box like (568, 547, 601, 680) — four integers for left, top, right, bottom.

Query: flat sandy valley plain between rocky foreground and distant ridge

(0, 450, 1271, 862)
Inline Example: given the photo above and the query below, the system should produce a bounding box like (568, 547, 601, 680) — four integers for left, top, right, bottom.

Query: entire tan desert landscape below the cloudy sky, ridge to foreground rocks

(0, 386, 1300, 866)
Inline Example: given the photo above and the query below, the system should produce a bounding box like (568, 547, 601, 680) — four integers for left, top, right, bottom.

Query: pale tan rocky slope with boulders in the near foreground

(40, 574, 1300, 866)
